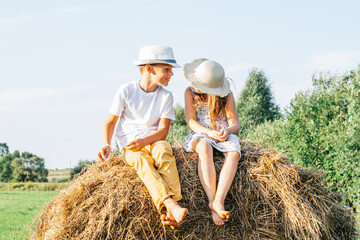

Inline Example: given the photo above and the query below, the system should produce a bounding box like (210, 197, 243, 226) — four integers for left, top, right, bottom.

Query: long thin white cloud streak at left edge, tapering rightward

(0, 85, 92, 104)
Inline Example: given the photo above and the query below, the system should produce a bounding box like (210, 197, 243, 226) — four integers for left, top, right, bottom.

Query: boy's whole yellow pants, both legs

(122, 140, 182, 211)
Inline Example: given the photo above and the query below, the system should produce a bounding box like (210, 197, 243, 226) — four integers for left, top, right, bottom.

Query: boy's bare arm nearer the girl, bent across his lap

(125, 118, 171, 151)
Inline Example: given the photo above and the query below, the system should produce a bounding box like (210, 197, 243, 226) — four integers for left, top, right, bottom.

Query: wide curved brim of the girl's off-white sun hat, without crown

(184, 58, 230, 97)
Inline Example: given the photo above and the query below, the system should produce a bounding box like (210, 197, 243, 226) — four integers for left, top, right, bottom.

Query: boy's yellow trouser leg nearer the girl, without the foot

(145, 140, 182, 201)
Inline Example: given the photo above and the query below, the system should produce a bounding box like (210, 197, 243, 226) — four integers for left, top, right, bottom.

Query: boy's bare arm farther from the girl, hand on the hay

(97, 113, 119, 162)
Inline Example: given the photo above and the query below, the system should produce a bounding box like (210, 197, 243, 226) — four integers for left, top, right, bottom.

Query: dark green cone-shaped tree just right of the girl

(236, 69, 281, 138)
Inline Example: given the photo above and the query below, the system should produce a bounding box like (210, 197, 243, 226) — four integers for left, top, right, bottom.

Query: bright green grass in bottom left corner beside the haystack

(0, 191, 57, 240)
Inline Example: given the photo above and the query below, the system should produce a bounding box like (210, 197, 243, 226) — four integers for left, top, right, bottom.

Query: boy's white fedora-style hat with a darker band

(134, 45, 180, 68)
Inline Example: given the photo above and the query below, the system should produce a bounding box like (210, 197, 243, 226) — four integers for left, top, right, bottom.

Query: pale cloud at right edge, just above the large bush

(310, 51, 360, 71)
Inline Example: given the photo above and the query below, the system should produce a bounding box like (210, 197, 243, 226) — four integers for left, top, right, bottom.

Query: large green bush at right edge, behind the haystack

(247, 66, 360, 210)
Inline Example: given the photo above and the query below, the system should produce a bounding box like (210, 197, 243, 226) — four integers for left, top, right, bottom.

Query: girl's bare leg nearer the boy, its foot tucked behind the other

(193, 140, 224, 225)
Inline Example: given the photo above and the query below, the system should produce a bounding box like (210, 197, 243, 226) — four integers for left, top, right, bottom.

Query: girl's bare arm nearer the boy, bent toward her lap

(184, 87, 217, 138)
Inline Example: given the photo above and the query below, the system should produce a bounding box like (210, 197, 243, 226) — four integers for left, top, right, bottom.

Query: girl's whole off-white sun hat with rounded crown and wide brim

(184, 58, 230, 97)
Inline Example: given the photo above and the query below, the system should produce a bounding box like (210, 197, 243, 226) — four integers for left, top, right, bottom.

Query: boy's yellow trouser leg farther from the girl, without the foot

(122, 149, 174, 210)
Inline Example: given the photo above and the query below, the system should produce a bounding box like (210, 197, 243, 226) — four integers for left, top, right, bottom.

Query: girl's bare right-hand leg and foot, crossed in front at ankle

(209, 152, 240, 221)
